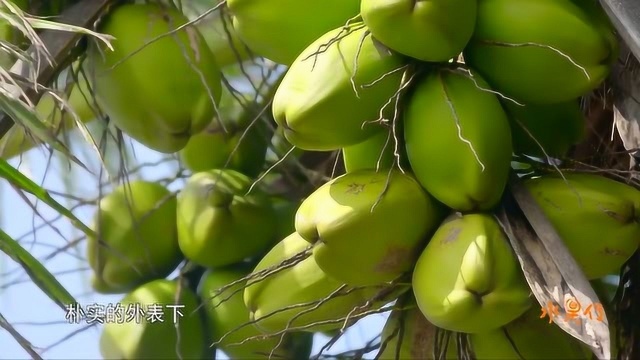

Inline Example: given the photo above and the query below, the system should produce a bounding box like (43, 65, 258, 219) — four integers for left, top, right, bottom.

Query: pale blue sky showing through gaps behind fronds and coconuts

(0, 129, 386, 359)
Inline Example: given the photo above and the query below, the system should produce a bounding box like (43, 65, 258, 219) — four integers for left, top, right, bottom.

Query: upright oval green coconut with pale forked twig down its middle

(404, 67, 512, 211)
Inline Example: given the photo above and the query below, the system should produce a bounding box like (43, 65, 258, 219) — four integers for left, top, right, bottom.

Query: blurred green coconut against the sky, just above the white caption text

(87, 180, 184, 293)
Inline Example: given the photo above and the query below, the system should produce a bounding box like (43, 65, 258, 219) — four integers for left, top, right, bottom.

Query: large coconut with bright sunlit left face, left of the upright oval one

(273, 23, 405, 151)
